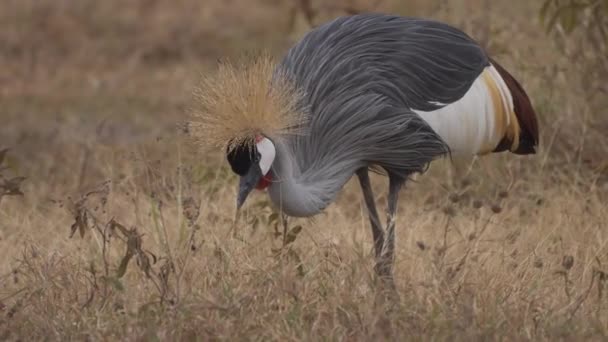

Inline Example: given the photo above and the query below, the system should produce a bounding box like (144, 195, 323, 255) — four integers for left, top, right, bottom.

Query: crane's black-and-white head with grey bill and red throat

(227, 135, 276, 209)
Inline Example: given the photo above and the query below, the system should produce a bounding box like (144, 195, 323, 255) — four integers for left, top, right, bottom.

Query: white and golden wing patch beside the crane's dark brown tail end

(414, 65, 519, 155)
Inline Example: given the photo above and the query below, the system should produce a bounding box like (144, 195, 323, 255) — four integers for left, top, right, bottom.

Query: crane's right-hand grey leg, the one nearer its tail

(376, 175, 403, 288)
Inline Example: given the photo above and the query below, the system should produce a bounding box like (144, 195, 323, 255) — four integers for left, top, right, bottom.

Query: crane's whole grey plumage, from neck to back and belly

(269, 14, 488, 216)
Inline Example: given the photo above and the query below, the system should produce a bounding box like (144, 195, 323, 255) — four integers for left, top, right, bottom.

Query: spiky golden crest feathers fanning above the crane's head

(190, 54, 305, 149)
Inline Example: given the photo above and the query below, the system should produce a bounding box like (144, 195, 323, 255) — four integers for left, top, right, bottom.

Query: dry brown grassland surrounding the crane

(0, 0, 608, 340)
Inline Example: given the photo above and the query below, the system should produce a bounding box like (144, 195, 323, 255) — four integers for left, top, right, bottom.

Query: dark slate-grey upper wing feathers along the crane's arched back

(283, 14, 489, 111)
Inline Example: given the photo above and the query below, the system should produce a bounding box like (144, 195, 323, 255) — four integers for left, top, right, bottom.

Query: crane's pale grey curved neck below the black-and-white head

(268, 139, 358, 217)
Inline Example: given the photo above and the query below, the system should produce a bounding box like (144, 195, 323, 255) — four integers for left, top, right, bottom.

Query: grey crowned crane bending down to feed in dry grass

(192, 14, 538, 279)
